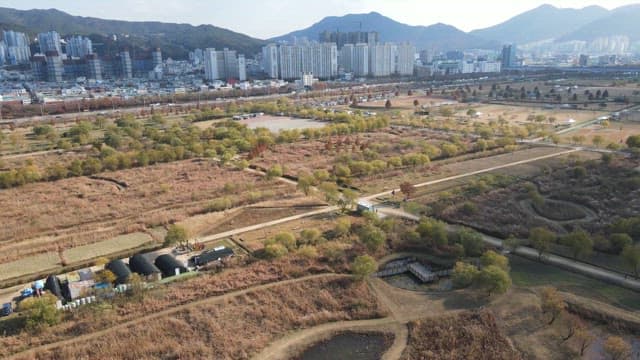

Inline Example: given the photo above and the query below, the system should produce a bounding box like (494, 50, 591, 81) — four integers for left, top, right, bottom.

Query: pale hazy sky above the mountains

(0, 0, 640, 39)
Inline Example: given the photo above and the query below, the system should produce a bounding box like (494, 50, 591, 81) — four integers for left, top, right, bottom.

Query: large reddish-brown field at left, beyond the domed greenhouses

(0, 160, 296, 261)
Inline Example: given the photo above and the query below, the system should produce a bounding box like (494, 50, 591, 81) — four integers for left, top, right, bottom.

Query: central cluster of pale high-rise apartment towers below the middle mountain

(262, 31, 416, 80)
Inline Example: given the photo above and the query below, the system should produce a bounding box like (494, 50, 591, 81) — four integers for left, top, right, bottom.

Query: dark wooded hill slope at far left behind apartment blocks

(0, 8, 264, 58)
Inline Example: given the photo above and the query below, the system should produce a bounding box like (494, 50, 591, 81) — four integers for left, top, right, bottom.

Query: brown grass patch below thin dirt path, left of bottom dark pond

(27, 279, 382, 359)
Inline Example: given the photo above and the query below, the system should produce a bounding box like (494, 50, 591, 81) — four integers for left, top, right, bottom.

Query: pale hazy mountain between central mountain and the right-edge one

(470, 5, 610, 44)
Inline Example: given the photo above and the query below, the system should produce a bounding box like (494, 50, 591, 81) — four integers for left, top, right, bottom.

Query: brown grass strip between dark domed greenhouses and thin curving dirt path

(0, 257, 344, 358)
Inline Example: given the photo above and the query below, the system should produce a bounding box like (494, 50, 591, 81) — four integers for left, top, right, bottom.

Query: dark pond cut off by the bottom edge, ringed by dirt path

(295, 332, 393, 360)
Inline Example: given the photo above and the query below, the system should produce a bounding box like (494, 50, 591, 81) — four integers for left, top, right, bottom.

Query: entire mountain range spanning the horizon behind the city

(0, 4, 640, 59)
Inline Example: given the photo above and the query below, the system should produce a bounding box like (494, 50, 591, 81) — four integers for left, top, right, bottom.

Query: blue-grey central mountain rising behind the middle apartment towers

(271, 12, 498, 50)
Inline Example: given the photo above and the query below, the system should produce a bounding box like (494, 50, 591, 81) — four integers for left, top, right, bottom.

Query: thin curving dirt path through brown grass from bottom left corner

(8, 274, 349, 359)
